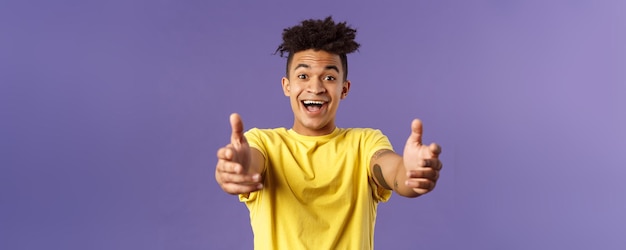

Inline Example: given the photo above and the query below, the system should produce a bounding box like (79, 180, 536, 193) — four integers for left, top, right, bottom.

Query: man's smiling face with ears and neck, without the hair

(282, 49, 350, 136)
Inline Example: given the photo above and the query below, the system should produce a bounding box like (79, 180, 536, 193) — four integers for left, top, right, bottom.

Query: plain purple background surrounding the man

(0, 0, 626, 250)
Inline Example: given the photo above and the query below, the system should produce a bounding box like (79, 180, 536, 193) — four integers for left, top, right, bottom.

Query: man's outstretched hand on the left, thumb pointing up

(215, 114, 263, 194)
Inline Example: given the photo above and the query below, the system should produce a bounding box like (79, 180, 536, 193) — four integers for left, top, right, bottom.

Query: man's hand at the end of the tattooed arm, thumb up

(403, 119, 443, 195)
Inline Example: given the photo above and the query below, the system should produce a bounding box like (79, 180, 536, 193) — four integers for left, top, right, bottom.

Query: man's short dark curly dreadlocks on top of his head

(274, 16, 361, 80)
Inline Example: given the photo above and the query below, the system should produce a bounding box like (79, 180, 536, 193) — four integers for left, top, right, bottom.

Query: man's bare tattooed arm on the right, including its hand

(370, 119, 442, 197)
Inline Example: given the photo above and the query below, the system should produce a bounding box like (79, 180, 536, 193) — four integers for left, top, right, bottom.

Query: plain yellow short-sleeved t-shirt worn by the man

(239, 128, 393, 250)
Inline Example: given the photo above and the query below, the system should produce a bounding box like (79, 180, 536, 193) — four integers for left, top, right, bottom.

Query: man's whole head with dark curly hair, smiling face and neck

(276, 17, 359, 136)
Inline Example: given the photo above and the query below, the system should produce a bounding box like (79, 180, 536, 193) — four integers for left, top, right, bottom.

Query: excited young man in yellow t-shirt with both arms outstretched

(215, 17, 442, 249)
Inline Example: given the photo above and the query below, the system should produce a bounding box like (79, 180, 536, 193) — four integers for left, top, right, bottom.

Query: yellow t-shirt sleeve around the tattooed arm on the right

(364, 129, 393, 202)
